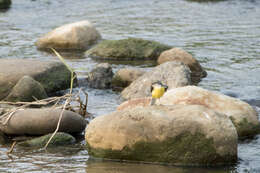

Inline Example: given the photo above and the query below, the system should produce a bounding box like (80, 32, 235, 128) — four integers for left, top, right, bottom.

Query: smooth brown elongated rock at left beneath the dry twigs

(0, 108, 86, 135)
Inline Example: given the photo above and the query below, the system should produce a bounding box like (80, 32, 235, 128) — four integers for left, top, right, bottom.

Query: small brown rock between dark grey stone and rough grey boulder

(112, 68, 145, 90)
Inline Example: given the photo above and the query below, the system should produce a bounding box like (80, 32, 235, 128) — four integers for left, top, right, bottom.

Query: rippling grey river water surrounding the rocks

(0, 0, 260, 173)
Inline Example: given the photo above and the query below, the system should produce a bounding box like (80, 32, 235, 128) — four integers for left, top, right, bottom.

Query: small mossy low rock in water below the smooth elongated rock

(18, 132, 76, 147)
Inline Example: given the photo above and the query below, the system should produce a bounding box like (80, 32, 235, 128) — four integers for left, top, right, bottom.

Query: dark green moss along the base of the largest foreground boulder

(87, 132, 237, 165)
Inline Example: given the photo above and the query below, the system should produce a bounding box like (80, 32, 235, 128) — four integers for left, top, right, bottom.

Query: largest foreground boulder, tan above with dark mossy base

(85, 105, 237, 165)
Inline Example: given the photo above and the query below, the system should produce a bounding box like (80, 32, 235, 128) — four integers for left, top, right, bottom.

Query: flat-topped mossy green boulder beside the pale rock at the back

(86, 38, 171, 60)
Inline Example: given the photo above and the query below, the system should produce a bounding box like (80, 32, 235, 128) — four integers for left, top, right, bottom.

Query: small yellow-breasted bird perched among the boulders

(150, 81, 168, 105)
